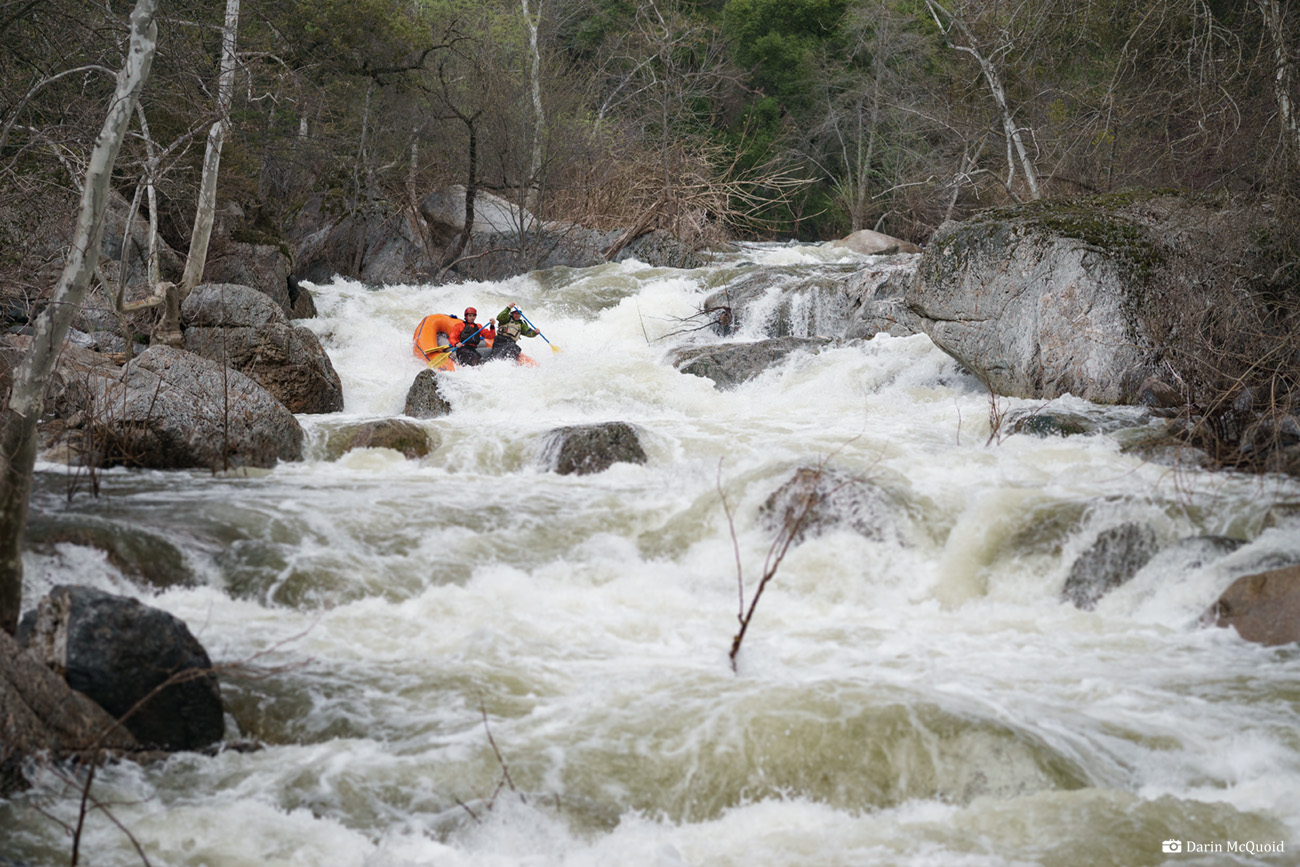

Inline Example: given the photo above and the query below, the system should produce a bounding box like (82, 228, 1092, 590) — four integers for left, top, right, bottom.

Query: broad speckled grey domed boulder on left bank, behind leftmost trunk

(91, 346, 303, 469)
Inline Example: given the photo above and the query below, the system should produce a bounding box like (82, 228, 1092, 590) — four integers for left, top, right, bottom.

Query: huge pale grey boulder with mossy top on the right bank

(906, 194, 1260, 403)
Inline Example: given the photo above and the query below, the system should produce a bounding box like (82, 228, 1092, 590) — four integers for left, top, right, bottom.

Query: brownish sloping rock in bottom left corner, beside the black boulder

(0, 629, 138, 797)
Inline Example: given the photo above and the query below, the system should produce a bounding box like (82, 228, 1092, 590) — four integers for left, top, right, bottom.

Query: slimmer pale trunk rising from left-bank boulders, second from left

(169, 0, 239, 344)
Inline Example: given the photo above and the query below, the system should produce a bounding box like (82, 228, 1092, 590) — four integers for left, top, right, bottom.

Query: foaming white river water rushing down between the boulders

(0, 247, 1300, 867)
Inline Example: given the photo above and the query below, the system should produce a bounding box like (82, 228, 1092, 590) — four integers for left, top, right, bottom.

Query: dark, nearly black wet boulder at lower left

(22, 585, 225, 750)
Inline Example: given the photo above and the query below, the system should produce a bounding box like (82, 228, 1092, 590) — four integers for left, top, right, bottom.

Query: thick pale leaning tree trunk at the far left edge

(0, 0, 157, 633)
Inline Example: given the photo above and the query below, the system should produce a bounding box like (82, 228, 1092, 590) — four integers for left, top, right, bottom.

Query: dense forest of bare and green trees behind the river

(0, 0, 1300, 290)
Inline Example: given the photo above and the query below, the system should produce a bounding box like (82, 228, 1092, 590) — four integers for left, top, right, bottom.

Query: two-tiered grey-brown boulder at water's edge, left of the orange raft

(181, 283, 343, 413)
